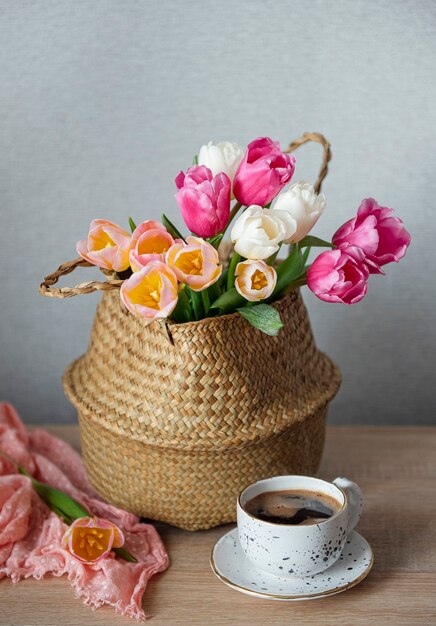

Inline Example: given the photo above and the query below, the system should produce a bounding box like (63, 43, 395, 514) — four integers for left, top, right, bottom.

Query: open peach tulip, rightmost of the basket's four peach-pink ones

(166, 237, 222, 291)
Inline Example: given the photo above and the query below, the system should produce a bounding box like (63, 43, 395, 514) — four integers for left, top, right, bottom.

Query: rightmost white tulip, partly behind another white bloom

(273, 182, 326, 243)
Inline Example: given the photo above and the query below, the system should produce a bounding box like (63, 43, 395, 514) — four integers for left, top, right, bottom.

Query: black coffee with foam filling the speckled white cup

(244, 489, 341, 526)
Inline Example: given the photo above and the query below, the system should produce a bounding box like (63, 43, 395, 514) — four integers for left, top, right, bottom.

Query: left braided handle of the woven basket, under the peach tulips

(39, 258, 124, 298)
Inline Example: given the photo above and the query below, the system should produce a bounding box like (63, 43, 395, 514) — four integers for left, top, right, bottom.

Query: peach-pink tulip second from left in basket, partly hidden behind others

(129, 220, 174, 272)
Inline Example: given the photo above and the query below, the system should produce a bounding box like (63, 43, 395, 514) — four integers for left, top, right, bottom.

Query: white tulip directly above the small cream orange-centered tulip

(231, 205, 297, 260)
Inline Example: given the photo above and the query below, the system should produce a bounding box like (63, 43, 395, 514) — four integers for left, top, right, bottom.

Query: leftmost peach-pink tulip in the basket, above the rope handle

(76, 220, 130, 272)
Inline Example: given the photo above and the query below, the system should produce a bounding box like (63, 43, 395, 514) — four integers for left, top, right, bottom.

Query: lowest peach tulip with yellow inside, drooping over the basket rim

(120, 261, 178, 320)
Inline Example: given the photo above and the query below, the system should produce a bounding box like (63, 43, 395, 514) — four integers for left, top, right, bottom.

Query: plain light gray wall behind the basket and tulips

(0, 0, 436, 424)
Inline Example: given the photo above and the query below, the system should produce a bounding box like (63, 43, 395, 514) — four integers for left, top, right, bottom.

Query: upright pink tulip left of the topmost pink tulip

(176, 165, 232, 237)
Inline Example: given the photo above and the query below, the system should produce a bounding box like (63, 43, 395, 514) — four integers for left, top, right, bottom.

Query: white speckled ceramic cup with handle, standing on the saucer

(237, 476, 363, 578)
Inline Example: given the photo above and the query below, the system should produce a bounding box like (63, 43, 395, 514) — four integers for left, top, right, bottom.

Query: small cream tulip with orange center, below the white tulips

(235, 260, 277, 302)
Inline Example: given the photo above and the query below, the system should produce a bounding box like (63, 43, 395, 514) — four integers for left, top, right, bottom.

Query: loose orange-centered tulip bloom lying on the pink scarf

(62, 517, 124, 565)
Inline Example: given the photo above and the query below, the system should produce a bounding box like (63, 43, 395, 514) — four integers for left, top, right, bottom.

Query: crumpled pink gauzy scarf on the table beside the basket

(0, 404, 169, 620)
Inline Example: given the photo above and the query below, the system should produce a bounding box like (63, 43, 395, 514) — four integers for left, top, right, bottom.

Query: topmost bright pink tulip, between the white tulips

(233, 137, 295, 206)
